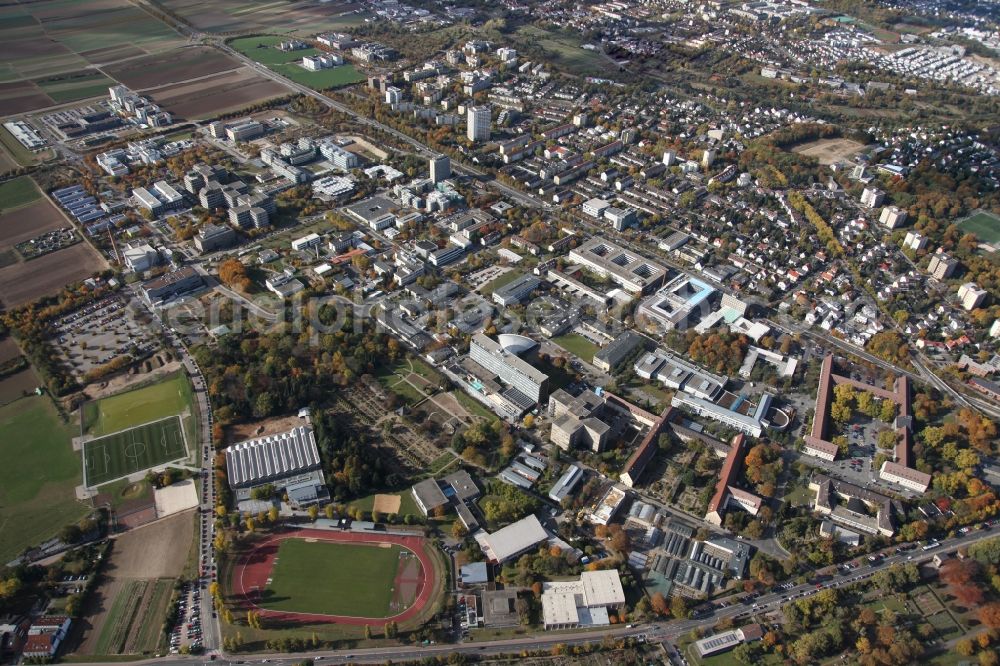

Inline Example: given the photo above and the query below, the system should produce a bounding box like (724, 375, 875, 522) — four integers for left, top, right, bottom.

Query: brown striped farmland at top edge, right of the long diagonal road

(160, 0, 364, 36)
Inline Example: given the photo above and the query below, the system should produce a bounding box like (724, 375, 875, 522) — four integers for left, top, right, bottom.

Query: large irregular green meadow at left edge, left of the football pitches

(0, 396, 88, 565)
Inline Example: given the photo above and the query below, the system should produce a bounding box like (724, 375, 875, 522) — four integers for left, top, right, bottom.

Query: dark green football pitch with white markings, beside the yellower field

(83, 416, 188, 488)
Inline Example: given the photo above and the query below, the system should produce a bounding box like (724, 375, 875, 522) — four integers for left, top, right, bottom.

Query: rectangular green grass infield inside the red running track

(261, 539, 402, 618)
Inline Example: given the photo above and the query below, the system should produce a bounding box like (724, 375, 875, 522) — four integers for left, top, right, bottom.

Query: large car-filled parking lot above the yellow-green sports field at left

(53, 295, 159, 378)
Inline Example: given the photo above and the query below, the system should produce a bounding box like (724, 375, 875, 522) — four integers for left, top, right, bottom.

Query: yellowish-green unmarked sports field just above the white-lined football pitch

(82, 372, 193, 435)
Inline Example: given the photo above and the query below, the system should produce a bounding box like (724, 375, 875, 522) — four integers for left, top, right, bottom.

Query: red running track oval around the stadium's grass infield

(232, 529, 435, 626)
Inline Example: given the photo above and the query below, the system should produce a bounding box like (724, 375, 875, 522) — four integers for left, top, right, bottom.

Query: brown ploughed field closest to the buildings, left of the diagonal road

(149, 67, 291, 120)
